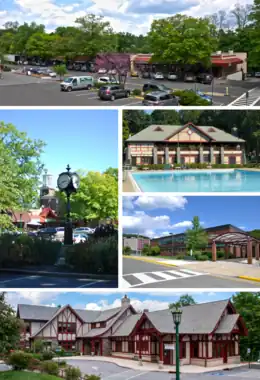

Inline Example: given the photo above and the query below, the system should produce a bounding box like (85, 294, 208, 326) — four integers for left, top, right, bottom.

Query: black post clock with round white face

(57, 165, 80, 246)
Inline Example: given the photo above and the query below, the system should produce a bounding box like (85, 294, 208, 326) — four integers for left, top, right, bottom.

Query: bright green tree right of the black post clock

(57, 171, 118, 221)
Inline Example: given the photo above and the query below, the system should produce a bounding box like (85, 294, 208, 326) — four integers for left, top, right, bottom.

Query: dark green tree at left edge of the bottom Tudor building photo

(0, 293, 21, 354)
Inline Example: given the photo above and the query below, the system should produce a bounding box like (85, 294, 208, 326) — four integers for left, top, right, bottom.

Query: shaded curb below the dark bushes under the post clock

(0, 268, 118, 280)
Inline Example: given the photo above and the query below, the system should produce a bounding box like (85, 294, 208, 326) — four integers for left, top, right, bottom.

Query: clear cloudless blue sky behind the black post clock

(0, 110, 118, 184)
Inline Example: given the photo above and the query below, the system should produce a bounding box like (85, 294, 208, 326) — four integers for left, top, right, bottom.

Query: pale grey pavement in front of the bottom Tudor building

(62, 359, 260, 380)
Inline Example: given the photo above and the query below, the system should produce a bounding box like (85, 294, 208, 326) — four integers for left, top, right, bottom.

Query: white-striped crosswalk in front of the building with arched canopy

(122, 269, 206, 288)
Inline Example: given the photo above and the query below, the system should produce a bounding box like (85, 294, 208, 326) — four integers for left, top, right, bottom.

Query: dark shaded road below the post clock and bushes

(0, 273, 118, 289)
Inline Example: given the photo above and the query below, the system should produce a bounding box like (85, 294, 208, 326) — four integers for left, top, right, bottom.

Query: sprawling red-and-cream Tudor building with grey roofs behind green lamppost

(17, 296, 247, 366)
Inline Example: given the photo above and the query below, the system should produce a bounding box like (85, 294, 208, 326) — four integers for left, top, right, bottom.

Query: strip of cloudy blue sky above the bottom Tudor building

(6, 290, 238, 311)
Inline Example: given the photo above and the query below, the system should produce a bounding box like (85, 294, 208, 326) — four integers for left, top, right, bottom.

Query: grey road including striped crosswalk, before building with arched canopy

(122, 258, 260, 289)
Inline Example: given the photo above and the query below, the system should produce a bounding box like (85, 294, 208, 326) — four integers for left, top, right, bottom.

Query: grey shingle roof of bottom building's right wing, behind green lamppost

(146, 300, 229, 334)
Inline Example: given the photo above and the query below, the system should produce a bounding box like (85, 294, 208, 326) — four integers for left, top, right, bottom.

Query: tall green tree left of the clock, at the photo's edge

(0, 122, 45, 228)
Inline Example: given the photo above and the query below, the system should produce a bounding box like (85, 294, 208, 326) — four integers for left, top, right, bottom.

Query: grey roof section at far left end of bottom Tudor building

(18, 304, 58, 321)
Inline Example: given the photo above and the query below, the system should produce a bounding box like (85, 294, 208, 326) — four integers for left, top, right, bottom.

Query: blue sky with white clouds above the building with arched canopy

(122, 195, 260, 237)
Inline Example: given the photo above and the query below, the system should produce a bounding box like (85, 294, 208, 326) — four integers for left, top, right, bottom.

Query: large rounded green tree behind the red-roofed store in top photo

(148, 14, 217, 66)
